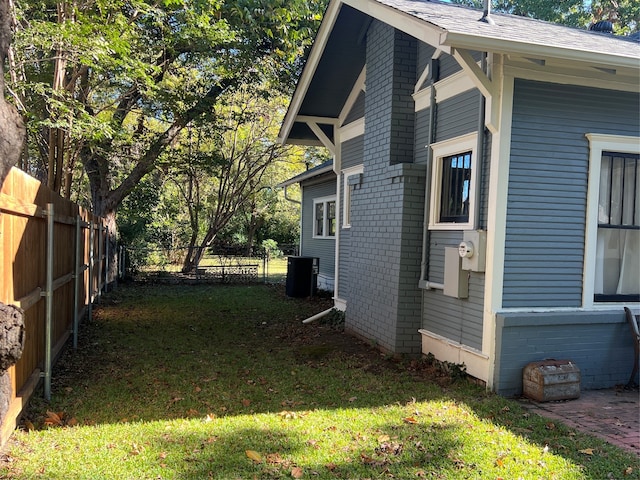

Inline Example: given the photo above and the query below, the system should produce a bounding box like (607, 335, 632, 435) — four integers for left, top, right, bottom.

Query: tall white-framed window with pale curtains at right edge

(584, 134, 640, 304)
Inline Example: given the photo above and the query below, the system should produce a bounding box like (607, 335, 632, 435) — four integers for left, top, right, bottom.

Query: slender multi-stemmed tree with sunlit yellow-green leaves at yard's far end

(162, 86, 302, 272)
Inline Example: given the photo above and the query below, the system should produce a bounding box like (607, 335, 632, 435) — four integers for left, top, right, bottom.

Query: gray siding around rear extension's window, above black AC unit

(300, 179, 336, 278)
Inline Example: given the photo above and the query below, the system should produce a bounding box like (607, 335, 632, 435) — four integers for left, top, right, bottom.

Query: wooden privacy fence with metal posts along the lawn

(0, 168, 110, 444)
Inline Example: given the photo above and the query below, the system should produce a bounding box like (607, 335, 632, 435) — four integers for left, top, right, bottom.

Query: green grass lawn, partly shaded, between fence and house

(0, 284, 640, 480)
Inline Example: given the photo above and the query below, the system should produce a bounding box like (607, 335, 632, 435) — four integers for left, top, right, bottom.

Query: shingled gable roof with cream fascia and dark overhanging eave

(280, 0, 640, 145)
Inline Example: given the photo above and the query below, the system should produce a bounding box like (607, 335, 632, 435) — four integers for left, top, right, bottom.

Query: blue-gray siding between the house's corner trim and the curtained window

(503, 80, 640, 307)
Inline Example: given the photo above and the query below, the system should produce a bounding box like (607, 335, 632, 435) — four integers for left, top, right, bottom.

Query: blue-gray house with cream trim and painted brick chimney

(280, 0, 640, 395)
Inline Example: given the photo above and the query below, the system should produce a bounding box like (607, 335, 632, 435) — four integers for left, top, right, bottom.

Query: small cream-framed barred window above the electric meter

(429, 133, 478, 230)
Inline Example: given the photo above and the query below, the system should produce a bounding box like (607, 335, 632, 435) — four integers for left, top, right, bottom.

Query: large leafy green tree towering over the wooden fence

(5, 0, 322, 278)
